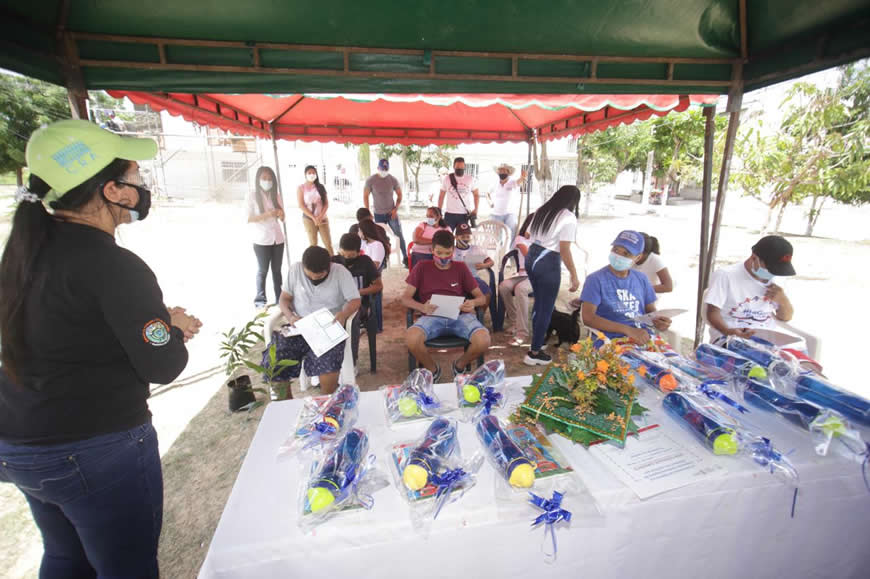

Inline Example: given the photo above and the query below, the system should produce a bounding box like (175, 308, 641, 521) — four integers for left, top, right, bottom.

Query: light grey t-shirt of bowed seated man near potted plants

(283, 261, 359, 316)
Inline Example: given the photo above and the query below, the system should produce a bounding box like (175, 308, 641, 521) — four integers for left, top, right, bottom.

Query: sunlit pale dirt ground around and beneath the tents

(0, 187, 870, 578)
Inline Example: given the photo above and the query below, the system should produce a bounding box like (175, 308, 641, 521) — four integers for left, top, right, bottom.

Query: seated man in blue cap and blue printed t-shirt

(580, 230, 671, 344)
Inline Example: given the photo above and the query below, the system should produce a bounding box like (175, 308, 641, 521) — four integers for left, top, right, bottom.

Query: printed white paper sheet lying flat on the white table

(589, 426, 726, 500)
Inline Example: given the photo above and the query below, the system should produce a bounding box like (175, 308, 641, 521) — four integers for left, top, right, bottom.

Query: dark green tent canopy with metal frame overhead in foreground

(0, 0, 870, 94)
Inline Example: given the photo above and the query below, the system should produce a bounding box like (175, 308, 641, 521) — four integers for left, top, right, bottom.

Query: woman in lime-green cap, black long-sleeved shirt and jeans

(0, 120, 202, 577)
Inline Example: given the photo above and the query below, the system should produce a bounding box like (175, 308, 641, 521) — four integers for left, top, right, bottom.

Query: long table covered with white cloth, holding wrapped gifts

(199, 377, 870, 579)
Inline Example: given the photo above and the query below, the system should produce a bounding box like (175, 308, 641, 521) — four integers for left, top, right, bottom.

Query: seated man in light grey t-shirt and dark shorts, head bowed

(276, 245, 361, 394)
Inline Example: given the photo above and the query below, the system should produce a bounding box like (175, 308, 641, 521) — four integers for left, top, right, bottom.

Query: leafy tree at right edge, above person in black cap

(733, 65, 870, 235)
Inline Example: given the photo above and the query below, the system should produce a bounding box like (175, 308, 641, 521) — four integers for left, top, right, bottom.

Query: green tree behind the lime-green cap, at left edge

(0, 74, 70, 185)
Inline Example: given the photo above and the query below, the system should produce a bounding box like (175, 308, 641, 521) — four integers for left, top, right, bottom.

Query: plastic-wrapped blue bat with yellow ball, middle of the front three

(389, 417, 483, 529)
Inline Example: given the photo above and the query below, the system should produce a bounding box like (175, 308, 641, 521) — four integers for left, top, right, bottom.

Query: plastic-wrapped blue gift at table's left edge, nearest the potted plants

(278, 384, 359, 456)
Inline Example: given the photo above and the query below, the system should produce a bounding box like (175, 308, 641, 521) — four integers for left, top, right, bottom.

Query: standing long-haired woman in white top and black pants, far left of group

(245, 167, 284, 307)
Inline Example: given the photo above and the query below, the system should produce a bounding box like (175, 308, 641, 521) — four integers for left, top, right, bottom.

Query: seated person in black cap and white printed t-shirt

(704, 235, 805, 349)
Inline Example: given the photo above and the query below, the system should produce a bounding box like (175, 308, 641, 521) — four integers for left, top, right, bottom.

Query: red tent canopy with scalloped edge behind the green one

(110, 91, 717, 145)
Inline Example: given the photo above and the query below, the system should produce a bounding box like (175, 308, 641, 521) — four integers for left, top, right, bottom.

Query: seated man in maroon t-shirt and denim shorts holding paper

(402, 231, 490, 382)
